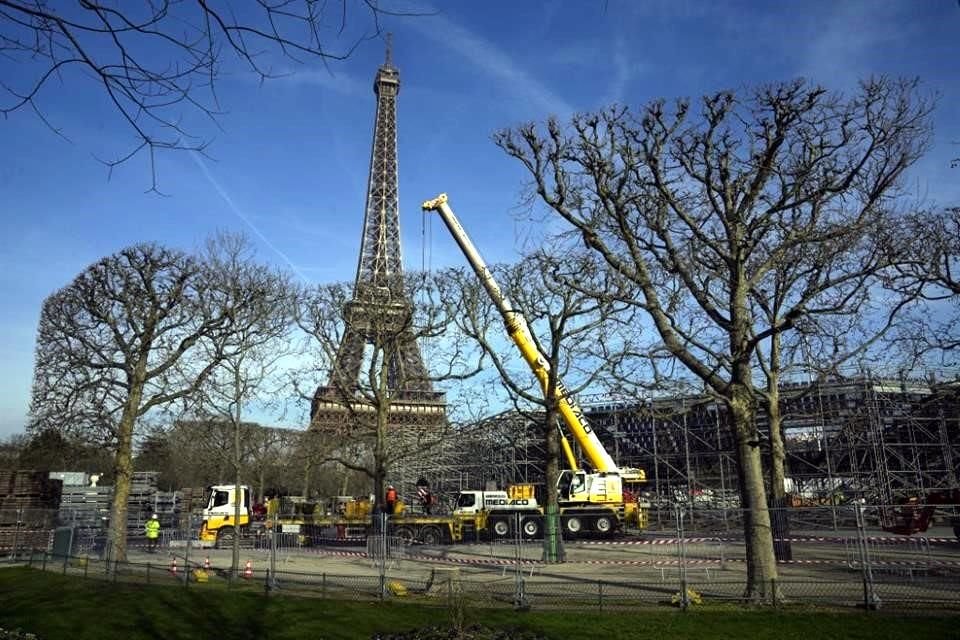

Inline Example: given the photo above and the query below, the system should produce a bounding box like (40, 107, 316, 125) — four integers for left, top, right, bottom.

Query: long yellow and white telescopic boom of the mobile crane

(422, 193, 645, 481)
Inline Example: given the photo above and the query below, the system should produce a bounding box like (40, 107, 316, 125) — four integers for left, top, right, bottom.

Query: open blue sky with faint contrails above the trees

(0, 0, 960, 437)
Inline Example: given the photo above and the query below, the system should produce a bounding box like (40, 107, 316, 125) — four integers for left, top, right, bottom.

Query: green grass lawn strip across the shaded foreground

(0, 567, 960, 640)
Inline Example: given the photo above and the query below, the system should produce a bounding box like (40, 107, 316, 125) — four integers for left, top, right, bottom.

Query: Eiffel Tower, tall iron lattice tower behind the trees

(310, 34, 446, 428)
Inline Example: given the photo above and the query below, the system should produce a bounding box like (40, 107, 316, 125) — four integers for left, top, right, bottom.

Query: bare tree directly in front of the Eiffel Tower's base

(296, 273, 480, 509)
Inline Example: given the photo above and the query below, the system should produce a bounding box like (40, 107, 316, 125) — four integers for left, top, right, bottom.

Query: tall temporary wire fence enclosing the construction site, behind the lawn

(5, 505, 960, 610)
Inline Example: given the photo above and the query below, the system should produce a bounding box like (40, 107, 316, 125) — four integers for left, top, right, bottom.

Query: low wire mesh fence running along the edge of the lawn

(15, 552, 960, 611)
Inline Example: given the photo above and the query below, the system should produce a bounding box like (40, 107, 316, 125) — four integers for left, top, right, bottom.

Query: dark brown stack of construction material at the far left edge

(0, 471, 62, 551)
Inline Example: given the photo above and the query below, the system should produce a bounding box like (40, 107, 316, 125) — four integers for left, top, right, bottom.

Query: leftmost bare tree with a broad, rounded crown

(28, 244, 247, 559)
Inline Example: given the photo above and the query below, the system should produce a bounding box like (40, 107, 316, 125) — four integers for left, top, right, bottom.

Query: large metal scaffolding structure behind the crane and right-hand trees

(434, 375, 960, 508)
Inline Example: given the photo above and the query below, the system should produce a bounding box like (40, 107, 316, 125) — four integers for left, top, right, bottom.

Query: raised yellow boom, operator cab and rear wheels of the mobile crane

(422, 193, 646, 535)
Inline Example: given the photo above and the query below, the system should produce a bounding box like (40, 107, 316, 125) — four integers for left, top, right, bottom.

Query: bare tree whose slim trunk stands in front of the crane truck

(454, 250, 636, 562)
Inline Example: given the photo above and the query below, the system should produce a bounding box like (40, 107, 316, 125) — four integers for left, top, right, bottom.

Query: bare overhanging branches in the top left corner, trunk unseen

(0, 0, 424, 189)
